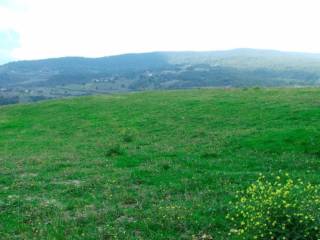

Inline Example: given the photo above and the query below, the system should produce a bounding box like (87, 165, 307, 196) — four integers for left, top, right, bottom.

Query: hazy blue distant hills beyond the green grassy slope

(0, 49, 320, 103)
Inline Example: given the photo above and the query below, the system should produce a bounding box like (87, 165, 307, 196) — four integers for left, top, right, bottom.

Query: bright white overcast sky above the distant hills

(0, 0, 320, 64)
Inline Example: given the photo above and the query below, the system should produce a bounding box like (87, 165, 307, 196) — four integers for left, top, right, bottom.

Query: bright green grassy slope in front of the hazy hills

(0, 89, 320, 239)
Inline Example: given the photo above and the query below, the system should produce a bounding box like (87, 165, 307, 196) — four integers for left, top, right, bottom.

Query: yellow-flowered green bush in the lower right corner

(227, 174, 320, 240)
